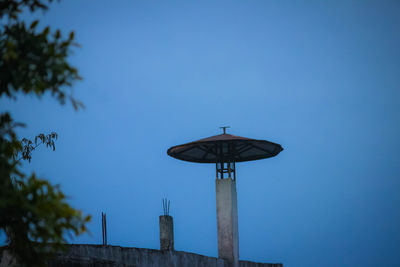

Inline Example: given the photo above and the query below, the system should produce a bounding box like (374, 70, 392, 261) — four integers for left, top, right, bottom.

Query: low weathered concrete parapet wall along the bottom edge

(0, 245, 283, 267)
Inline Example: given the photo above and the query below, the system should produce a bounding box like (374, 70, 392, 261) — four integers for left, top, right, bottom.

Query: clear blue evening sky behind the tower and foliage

(0, 0, 400, 267)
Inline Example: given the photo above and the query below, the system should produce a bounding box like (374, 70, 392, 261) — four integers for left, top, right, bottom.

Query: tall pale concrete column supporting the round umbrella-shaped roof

(215, 178, 239, 267)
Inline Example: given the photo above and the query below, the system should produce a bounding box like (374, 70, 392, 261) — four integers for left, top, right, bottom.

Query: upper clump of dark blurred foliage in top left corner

(0, 0, 83, 109)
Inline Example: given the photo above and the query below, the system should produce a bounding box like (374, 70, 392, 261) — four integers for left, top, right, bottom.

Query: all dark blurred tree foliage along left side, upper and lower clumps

(0, 0, 90, 266)
